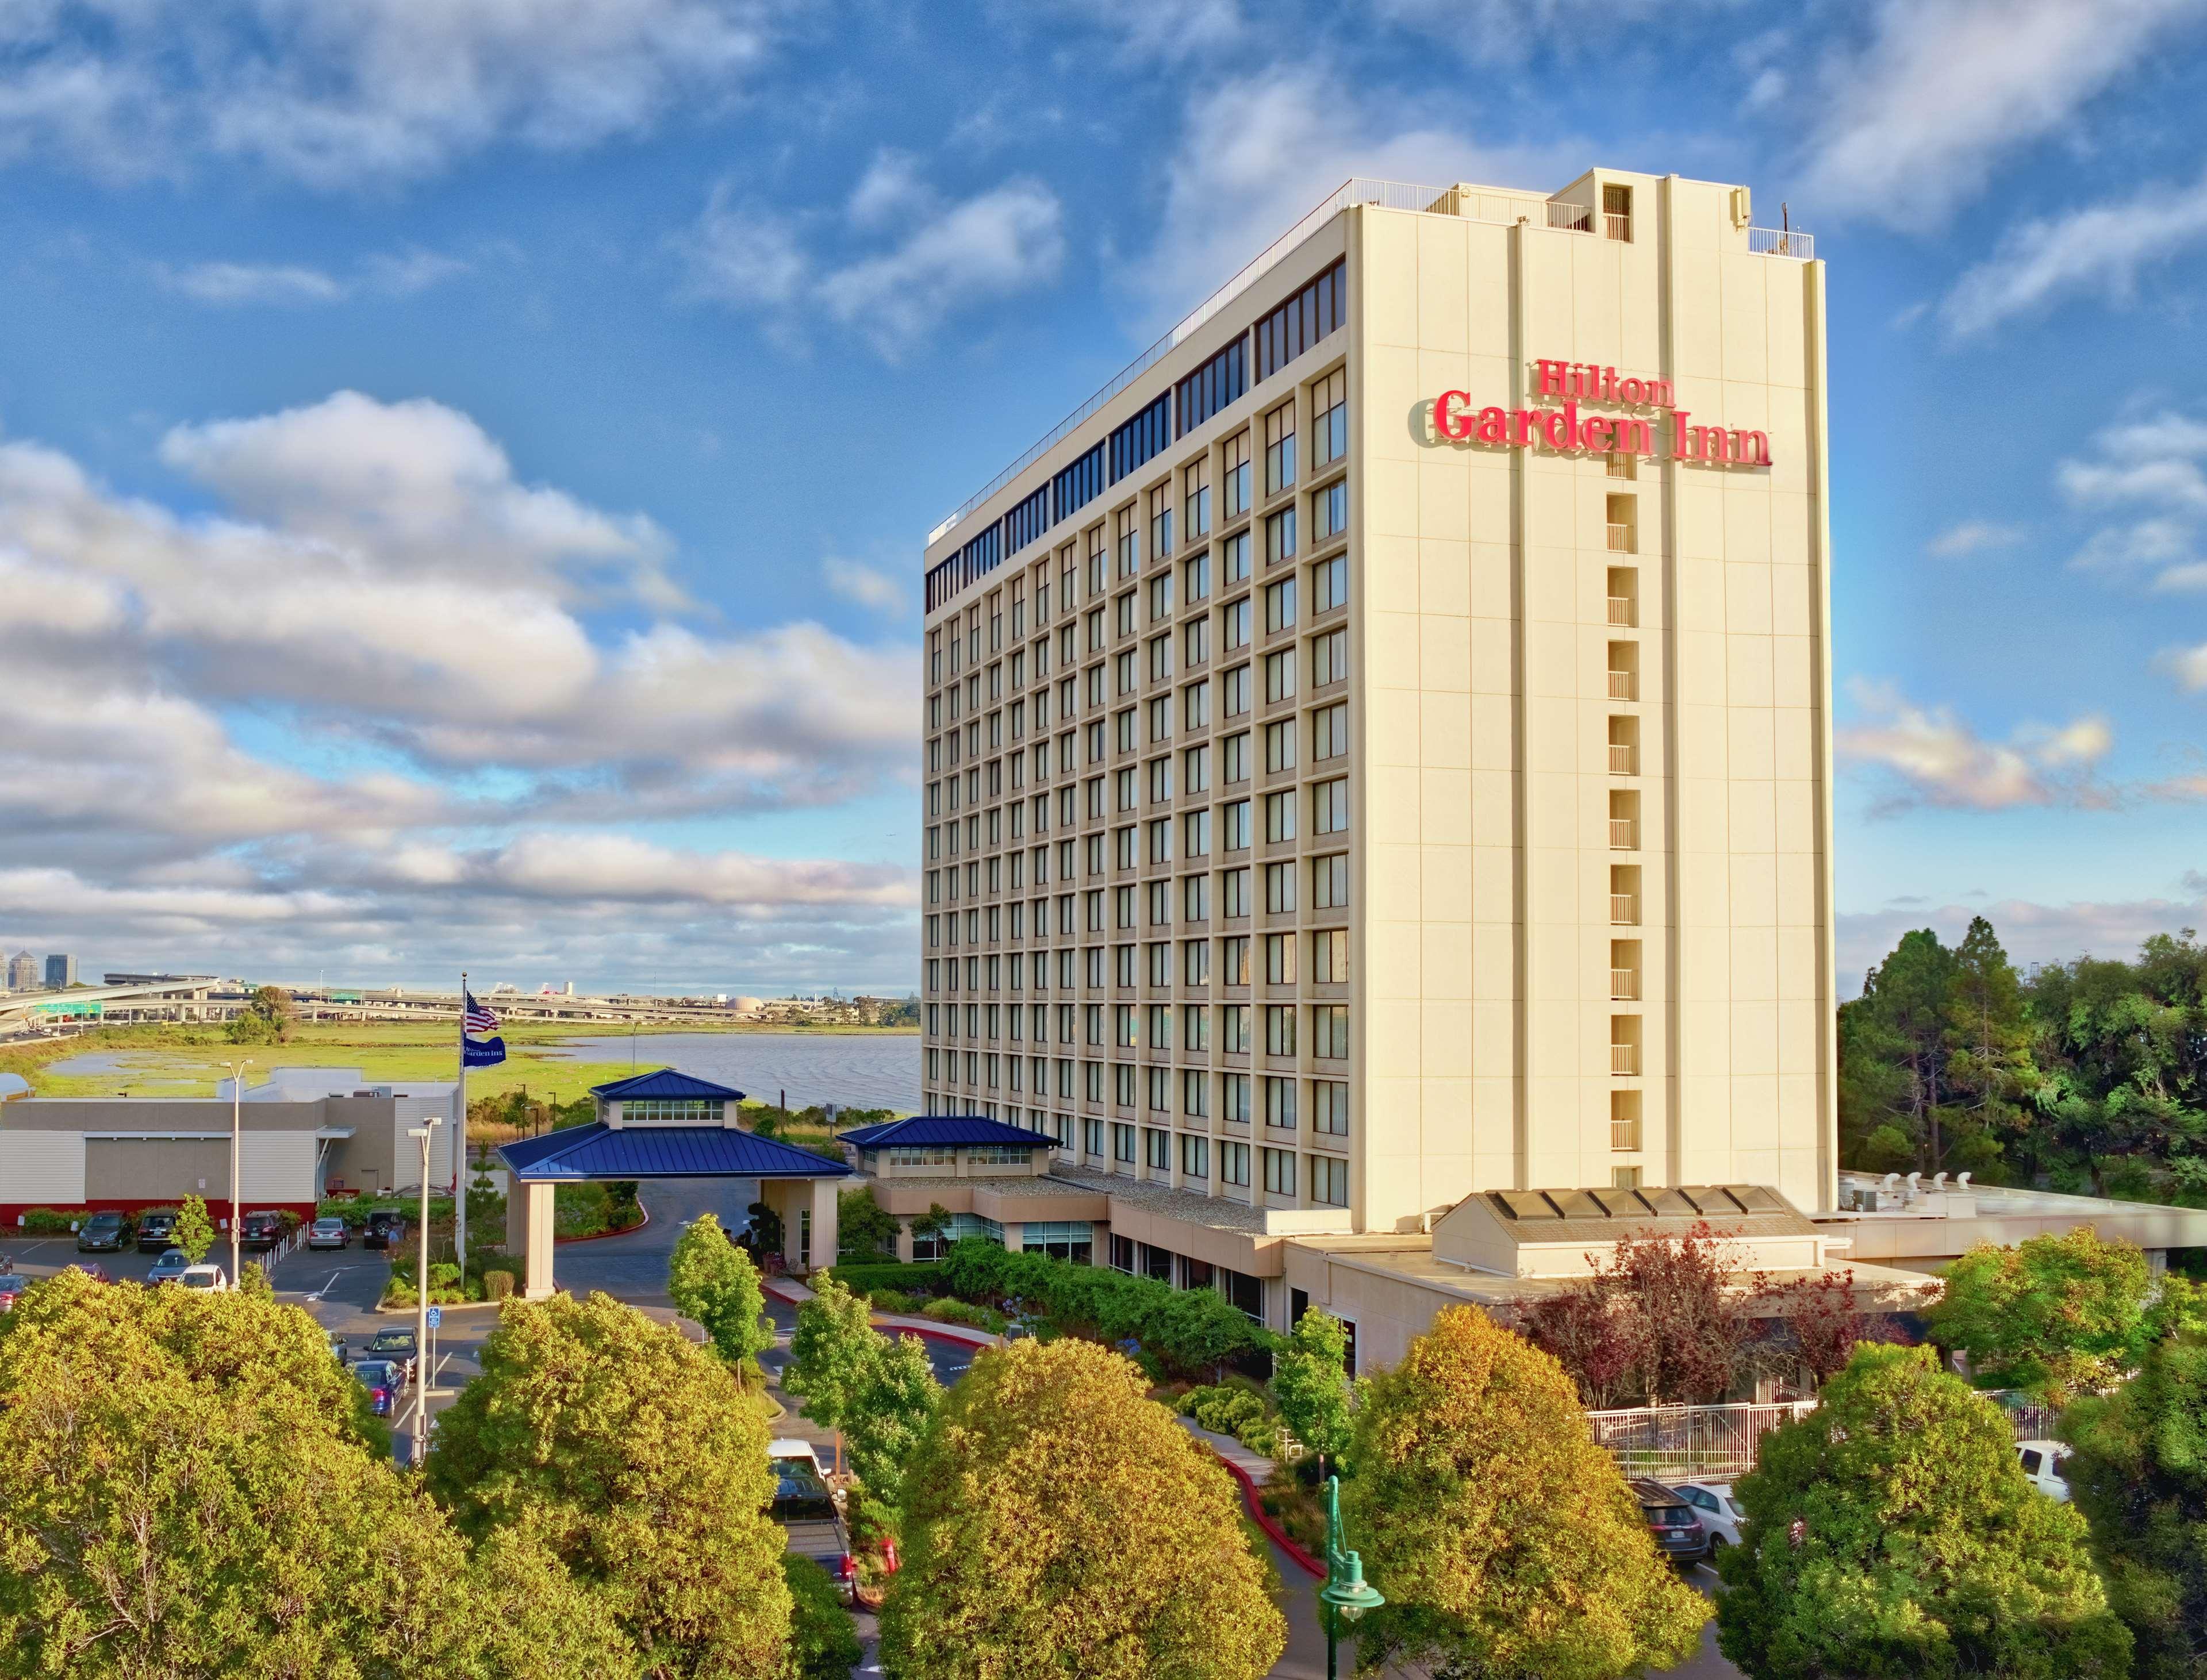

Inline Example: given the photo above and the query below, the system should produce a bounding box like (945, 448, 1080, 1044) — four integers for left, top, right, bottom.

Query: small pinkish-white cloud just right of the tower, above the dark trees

(1834, 682, 2117, 810)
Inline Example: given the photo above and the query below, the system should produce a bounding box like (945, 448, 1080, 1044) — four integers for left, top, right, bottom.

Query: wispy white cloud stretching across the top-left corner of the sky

(0, 0, 784, 187)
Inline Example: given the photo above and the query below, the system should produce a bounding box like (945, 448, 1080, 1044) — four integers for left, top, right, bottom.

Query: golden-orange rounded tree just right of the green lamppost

(1342, 1307, 1708, 1680)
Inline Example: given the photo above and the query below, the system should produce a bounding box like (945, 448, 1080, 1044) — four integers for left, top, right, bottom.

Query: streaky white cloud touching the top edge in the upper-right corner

(1799, 0, 2200, 229)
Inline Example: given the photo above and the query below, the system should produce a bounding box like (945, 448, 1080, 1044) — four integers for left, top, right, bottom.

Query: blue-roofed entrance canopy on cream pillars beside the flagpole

(499, 1068, 852, 1300)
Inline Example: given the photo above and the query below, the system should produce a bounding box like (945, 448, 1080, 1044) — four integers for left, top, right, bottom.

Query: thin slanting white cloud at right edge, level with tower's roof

(1940, 176, 2207, 336)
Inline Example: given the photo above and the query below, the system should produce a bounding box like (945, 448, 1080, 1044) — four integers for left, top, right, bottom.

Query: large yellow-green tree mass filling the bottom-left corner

(0, 1271, 636, 1680)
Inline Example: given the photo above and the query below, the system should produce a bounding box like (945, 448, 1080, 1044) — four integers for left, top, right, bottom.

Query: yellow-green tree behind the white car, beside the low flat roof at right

(1929, 1225, 2198, 1404)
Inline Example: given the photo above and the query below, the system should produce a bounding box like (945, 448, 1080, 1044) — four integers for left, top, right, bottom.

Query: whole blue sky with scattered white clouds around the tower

(0, 0, 2207, 991)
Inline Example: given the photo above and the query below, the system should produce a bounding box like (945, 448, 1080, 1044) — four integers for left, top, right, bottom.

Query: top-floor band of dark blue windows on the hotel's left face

(927, 260, 1349, 612)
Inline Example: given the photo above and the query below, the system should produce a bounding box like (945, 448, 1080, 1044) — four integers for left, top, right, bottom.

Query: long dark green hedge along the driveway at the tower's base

(942, 1236, 1271, 1371)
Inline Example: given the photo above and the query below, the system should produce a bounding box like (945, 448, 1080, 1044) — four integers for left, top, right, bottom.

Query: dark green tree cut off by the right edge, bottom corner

(2062, 1340, 2207, 1680)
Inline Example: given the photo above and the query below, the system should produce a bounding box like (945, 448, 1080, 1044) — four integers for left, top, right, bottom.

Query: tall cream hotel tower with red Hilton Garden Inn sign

(920, 170, 1836, 1271)
